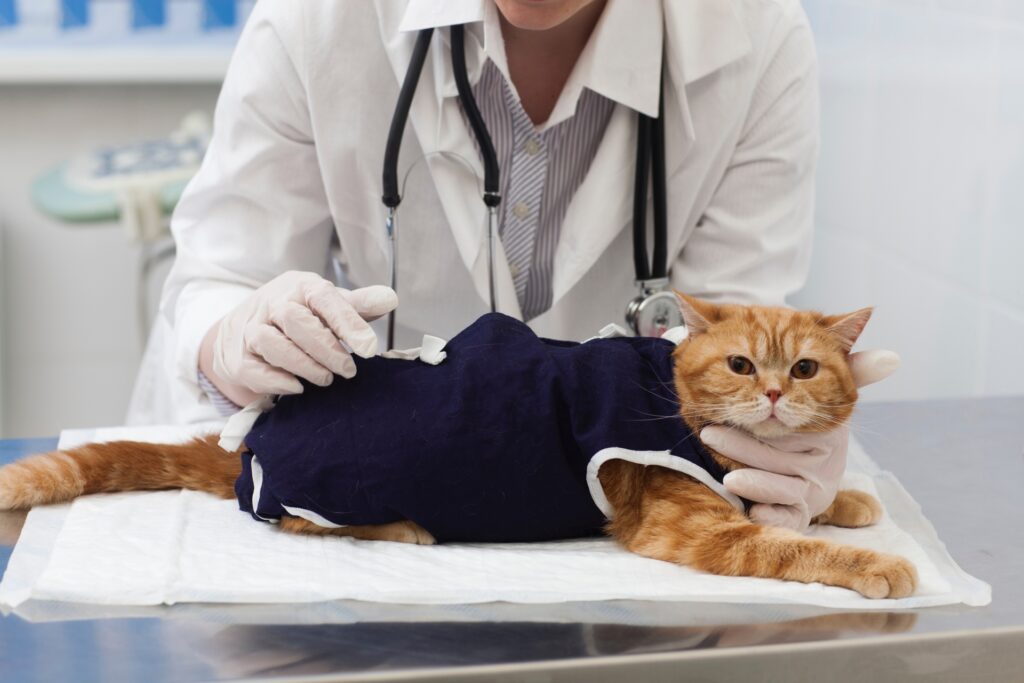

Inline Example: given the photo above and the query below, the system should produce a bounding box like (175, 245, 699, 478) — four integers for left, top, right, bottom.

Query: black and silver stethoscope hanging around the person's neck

(381, 25, 683, 348)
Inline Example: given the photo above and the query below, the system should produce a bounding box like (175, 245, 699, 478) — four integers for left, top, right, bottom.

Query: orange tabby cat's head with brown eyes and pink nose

(675, 294, 871, 437)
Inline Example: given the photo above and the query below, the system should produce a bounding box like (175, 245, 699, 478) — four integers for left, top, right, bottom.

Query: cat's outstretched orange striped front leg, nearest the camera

(612, 468, 918, 598)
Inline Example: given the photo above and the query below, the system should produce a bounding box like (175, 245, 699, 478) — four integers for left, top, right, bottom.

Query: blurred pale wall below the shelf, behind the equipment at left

(0, 85, 218, 437)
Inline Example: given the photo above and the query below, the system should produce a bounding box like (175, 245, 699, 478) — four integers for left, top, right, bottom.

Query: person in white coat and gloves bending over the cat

(129, 0, 897, 527)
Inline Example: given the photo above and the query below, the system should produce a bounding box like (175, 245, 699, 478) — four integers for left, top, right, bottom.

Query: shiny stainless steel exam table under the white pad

(0, 397, 1024, 683)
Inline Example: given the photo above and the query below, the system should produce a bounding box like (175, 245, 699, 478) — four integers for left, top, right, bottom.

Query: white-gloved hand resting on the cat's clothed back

(201, 270, 398, 405)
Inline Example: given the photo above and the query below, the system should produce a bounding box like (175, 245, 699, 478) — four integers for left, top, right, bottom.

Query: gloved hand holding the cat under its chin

(700, 351, 899, 531)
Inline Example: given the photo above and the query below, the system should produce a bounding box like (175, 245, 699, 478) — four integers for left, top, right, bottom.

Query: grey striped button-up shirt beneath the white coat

(473, 59, 614, 321)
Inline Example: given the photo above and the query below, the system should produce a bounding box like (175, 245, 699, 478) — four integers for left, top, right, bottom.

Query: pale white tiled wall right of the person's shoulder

(794, 0, 1024, 399)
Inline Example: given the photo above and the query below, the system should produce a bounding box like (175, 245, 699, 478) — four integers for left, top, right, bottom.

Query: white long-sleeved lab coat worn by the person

(123, 0, 818, 422)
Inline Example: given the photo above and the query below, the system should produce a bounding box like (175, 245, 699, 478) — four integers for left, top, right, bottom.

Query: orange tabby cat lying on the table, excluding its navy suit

(0, 296, 916, 598)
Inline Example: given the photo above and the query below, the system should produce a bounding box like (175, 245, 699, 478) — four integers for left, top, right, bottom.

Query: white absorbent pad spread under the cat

(0, 428, 991, 610)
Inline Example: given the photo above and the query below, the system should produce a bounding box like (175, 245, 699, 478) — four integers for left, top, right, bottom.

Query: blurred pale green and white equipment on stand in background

(32, 112, 211, 347)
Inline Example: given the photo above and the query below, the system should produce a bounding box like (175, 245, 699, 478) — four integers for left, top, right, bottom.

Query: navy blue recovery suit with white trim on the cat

(236, 313, 724, 542)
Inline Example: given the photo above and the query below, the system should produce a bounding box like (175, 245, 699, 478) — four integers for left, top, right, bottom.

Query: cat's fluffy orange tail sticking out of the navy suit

(0, 436, 242, 510)
